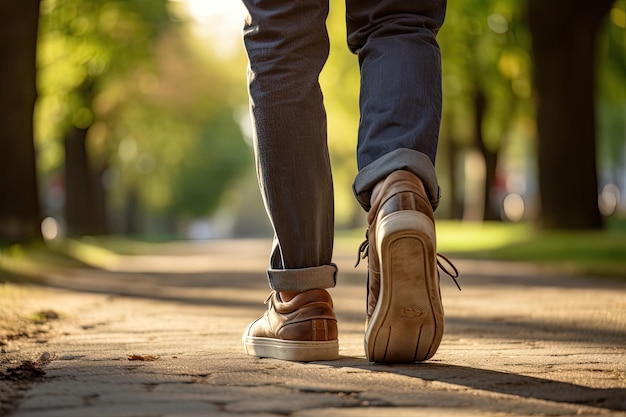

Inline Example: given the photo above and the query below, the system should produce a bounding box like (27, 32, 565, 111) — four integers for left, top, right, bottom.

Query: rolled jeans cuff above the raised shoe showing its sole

(352, 148, 440, 211)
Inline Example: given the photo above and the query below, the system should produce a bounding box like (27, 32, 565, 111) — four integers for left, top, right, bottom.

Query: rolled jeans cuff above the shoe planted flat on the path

(267, 264, 337, 292)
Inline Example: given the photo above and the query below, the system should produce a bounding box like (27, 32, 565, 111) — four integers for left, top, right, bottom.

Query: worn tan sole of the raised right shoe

(365, 210, 444, 363)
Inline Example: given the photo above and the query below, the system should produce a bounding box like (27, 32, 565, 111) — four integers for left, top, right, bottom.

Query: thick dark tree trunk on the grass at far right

(528, 0, 613, 229)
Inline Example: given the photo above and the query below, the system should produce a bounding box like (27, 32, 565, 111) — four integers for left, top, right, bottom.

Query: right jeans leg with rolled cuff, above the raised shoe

(346, 0, 446, 210)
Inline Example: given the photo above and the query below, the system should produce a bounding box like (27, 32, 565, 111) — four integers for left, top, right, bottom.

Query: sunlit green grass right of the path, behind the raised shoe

(338, 220, 626, 279)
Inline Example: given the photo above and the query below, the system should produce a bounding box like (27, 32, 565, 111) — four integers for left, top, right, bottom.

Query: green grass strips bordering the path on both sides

(0, 220, 626, 281)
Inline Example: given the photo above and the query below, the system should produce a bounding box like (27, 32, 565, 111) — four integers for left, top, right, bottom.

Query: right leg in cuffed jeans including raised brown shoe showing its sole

(347, 0, 446, 362)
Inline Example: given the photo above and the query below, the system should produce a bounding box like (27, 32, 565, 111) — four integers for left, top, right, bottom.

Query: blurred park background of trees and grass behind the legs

(0, 0, 626, 276)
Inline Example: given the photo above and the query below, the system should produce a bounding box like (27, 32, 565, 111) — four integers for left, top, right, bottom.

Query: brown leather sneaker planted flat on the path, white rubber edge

(242, 289, 339, 362)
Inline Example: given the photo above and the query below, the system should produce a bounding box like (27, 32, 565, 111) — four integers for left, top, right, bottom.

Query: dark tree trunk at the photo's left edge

(0, 0, 42, 244)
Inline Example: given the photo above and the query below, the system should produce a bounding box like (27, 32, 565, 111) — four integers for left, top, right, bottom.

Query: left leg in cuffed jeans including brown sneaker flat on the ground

(244, 0, 337, 360)
